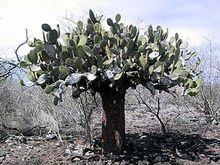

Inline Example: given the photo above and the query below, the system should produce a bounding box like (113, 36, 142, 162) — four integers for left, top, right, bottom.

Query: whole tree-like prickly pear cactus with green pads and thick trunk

(20, 10, 200, 154)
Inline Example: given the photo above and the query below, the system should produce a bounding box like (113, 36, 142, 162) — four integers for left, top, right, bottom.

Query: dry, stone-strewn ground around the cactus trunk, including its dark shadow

(0, 106, 220, 165)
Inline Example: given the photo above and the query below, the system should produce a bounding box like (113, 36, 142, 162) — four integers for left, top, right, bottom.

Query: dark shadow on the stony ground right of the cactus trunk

(115, 133, 220, 164)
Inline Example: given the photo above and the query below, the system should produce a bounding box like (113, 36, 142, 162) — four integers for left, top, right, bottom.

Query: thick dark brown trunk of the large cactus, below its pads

(101, 87, 125, 155)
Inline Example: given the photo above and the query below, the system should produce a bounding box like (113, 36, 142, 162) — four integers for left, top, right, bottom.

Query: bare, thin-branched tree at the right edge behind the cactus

(191, 38, 220, 124)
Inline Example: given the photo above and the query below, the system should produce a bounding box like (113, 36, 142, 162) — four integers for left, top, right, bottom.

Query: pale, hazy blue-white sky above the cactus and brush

(0, 0, 220, 58)
